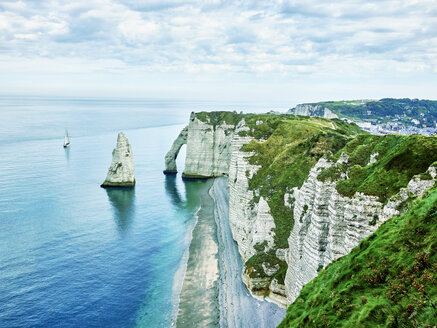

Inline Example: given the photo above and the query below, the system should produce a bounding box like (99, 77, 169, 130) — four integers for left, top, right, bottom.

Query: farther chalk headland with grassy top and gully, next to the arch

(167, 112, 359, 306)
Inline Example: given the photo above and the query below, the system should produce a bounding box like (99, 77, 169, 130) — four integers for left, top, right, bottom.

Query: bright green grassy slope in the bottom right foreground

(279, 188, 437, 327)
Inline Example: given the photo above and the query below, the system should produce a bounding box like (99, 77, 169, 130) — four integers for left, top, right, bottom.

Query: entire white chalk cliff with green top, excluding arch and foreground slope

(165, 112, 437, 312)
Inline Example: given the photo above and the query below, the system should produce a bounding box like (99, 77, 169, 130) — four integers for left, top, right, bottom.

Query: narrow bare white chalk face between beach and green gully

(228, 120, 286, 306)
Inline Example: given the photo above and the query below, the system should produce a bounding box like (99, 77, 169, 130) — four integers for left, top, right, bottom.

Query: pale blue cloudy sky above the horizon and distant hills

(0, 0, 437, 105)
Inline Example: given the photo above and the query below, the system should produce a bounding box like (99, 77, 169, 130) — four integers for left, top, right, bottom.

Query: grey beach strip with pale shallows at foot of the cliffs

(176, 178, 285, 328)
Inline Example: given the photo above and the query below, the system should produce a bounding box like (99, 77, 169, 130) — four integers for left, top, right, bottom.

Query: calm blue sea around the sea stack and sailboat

(0, 96, 286, 327)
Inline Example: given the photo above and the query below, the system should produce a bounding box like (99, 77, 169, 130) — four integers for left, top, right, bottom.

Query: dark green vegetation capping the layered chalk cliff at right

(318, 135, 437, 202)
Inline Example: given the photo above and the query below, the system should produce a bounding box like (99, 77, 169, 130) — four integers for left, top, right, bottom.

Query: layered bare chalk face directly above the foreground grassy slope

(284, 154, 437, 304)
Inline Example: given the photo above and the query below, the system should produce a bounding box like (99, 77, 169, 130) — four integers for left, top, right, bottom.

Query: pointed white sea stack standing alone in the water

(100, 132, 135, 188)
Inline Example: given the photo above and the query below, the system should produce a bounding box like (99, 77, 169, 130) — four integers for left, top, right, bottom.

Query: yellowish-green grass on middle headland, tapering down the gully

(242, 114, 363, 282)
